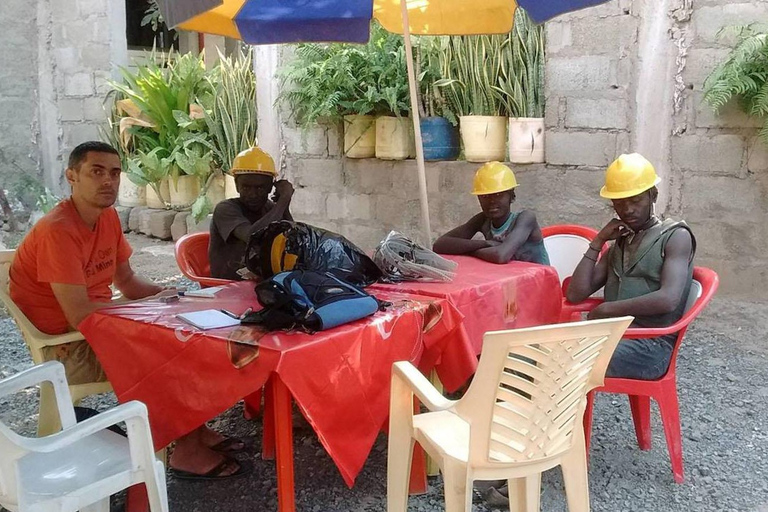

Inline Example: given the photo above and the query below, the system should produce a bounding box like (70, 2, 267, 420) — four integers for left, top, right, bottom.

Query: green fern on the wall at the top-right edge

(704, 23, 768, 145)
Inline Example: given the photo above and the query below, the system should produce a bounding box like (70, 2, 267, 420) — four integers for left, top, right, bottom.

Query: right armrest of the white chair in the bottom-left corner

(26, 400, 148, 453)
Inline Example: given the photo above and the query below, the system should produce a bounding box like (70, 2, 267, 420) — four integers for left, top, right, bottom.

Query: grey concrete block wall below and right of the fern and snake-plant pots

(274, 0, 768, 298)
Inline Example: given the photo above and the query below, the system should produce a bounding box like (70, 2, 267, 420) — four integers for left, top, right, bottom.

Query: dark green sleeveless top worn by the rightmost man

(605, 219, 696, 327)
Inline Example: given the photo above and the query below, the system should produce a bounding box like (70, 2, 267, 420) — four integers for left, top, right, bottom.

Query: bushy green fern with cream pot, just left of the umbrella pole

(277, 43, 376, 158)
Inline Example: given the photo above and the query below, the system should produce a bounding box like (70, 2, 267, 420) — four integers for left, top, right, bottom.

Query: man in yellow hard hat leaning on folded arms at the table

(433, 162, 549, 265)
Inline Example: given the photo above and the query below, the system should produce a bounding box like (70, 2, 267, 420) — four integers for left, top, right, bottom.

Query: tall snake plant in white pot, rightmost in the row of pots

(495, 9, 544, 163)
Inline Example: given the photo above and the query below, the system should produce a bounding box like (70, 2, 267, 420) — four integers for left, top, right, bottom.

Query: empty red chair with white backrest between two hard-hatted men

(541, 224, 608, 322)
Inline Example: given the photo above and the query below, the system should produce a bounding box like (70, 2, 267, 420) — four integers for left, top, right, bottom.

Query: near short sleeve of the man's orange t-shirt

(35, 226, 87, 286)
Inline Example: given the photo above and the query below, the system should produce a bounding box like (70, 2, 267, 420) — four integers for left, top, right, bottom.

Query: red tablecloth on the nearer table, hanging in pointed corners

(78, 282, 477, 485)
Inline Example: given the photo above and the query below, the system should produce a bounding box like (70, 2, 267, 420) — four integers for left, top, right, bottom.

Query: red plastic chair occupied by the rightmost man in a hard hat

(584, 267, 720, 484)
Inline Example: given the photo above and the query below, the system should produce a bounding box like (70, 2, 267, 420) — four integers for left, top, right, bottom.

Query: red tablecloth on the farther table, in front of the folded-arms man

(370, 256, 563, 354)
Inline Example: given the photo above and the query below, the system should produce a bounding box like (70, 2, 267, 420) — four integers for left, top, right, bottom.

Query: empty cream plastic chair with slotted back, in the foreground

(387, 317, 632, 512)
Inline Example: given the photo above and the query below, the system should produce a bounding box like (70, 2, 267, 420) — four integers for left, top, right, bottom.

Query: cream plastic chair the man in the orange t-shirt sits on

(0, 250, 112, 437)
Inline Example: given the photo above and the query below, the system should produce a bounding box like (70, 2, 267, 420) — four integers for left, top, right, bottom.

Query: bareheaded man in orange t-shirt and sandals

(9, 142, 249, 479)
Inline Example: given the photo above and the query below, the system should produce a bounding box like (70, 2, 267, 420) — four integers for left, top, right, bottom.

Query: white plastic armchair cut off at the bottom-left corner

(0, 361, 168, 512)
